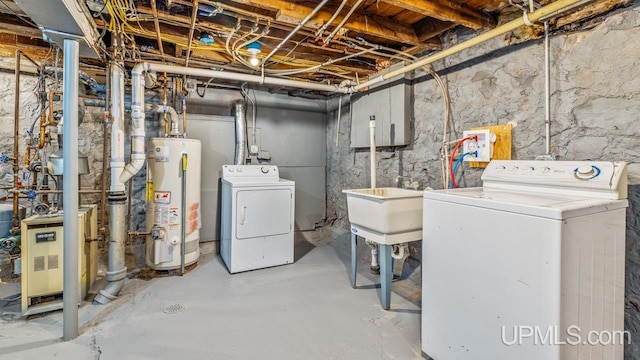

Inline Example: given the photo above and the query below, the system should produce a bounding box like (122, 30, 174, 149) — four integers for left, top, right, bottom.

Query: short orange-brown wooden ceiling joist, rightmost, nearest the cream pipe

(382, 0, 494, 30)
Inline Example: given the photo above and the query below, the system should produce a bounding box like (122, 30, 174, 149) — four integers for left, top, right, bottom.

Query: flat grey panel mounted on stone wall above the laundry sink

(351, 67, 411, 148)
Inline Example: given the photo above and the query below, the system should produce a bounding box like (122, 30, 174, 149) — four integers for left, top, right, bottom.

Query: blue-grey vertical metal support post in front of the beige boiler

(62, 39, 80, 341)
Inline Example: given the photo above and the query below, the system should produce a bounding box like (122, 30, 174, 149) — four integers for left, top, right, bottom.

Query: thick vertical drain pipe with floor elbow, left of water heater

(94, 63, 127, 304)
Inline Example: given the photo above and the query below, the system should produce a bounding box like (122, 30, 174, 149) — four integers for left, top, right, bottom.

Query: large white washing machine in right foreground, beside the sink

(422, 161, 628, 360)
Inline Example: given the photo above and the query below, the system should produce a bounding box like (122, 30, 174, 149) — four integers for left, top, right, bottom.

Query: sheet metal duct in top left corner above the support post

(15, 0, 104, 58)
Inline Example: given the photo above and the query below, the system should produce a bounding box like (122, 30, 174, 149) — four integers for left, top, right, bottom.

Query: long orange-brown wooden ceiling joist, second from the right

(228, 0, 419, 45)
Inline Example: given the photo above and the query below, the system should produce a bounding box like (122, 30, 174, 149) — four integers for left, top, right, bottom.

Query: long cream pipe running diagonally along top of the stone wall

(352, 0, 593, 91)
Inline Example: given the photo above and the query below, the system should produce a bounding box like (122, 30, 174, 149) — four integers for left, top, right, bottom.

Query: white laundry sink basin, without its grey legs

(342, 187, 423, 238)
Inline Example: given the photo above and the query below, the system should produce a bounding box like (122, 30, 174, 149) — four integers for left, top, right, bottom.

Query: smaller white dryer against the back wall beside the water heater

(220, 165, 295, 273)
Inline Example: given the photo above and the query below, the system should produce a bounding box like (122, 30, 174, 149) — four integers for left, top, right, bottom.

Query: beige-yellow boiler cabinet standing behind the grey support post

(21, 205, 98, 316)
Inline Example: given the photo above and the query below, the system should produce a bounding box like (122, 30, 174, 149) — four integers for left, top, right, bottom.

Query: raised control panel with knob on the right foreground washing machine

(482, 160, 627, 197)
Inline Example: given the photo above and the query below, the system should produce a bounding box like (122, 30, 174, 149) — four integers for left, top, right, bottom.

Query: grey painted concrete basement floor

(0, 233, 422, 360)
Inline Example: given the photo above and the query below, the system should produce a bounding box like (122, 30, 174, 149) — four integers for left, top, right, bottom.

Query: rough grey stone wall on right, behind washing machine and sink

(323, 5, 640, 359)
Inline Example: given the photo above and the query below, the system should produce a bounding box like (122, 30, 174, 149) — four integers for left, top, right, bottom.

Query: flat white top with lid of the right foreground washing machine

(424, 187, 628, 220)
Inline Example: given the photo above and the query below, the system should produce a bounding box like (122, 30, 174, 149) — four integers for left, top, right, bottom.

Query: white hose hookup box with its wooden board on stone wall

(463, 123, 512, 168)
